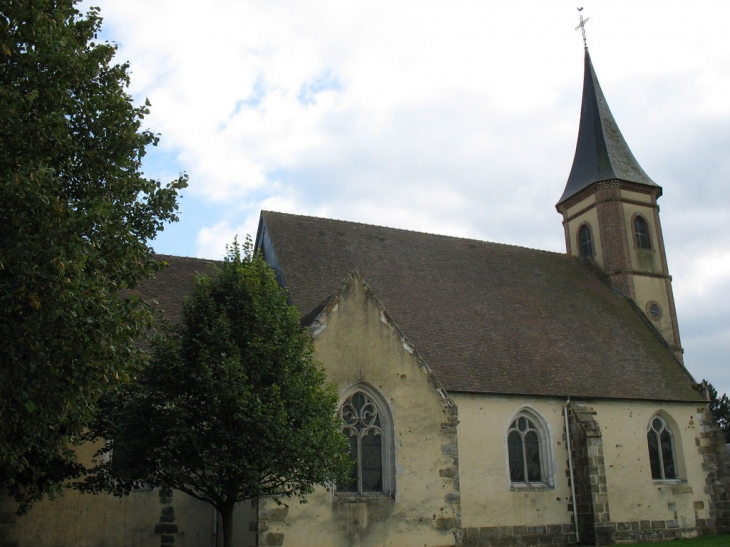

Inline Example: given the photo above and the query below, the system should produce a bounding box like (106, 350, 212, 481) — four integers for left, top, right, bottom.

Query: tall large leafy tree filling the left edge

(0, 0, 186, 512)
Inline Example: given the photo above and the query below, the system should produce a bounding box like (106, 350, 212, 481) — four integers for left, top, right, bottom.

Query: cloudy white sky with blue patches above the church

(82, 0, 730, 393)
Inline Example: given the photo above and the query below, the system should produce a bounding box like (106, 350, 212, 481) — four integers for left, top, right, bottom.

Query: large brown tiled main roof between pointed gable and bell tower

(257, 212, 702, 401)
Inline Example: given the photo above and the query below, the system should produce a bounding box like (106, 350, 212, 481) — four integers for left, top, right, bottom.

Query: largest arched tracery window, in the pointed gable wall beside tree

(337, 384, 395, 495)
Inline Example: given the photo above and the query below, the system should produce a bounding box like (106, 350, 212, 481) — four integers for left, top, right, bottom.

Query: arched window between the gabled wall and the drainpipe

(507, 409, 553, 488)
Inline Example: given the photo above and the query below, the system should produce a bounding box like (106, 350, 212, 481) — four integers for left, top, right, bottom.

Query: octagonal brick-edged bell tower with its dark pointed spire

(556, 48, 682, 362)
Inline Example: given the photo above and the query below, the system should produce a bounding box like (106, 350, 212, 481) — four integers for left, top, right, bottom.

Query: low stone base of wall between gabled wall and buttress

(462, 524, 576, 547)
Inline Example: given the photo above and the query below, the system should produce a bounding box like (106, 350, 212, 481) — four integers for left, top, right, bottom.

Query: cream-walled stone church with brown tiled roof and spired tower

(4, 50, 730, 547)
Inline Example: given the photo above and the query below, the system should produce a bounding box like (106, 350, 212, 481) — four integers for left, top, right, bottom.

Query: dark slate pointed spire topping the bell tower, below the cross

(558, 48, 661, 204)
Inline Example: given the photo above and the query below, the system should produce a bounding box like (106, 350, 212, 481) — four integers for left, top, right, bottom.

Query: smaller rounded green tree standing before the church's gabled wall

(79, 242, 350, 546)
